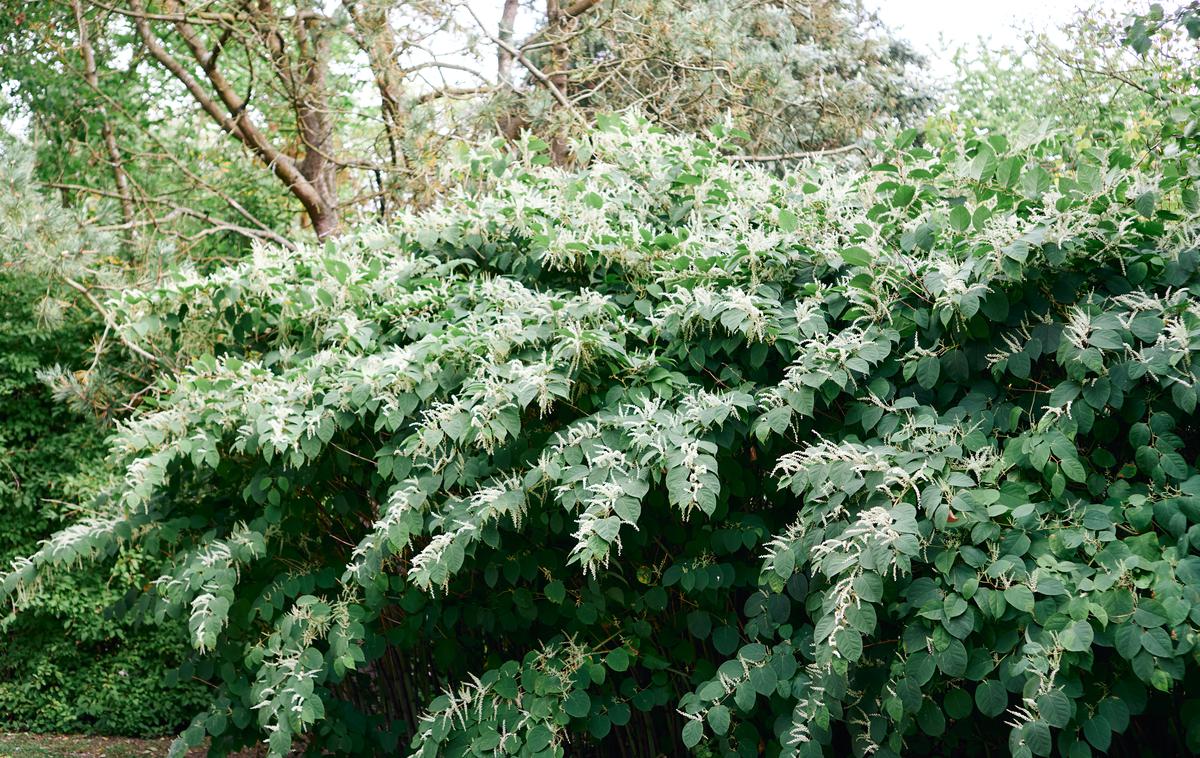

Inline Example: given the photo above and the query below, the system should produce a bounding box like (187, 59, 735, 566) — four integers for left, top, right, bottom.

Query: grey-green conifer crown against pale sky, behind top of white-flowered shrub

(516, 0, 931, 156)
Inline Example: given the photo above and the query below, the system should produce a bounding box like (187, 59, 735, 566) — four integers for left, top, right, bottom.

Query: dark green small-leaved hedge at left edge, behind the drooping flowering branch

(0, 272, 205, 735)
